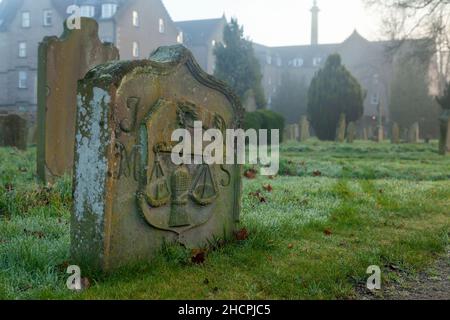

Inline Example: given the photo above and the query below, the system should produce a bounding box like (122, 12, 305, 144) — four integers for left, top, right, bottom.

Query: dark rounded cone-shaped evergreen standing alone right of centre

(308, 54, 364, 141)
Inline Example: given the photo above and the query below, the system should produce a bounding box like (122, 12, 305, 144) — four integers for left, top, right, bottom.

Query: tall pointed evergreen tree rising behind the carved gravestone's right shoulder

(214, 19, 266, 109)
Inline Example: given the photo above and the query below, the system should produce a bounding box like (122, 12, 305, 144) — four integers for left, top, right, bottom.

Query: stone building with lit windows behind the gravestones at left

(0, 0, 181, 116)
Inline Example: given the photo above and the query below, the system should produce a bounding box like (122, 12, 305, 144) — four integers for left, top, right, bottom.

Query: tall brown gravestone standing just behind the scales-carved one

(37, 18, 119, 182)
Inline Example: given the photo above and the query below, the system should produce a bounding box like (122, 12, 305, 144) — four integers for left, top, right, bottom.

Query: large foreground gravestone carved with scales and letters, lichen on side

(71, 46, 244, 270)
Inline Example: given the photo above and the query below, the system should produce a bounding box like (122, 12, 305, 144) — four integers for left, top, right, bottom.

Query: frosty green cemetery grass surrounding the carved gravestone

(0, 140, 450, 299)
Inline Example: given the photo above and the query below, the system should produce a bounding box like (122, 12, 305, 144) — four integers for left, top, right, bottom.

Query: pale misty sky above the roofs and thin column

(163, 0, 380, 46)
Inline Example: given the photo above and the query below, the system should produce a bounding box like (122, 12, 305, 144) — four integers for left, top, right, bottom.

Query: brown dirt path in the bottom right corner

(358, 249, 450, 300)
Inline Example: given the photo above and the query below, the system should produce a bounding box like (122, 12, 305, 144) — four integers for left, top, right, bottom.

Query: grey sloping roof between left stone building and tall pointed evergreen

(175, 16, 226, 46)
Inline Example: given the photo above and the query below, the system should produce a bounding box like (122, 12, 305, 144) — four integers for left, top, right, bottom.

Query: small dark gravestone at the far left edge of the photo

(0, 114, 27, 150)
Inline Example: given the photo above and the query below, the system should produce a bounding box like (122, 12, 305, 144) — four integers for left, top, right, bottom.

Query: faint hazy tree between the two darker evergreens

(272, 72, 308, 124)
